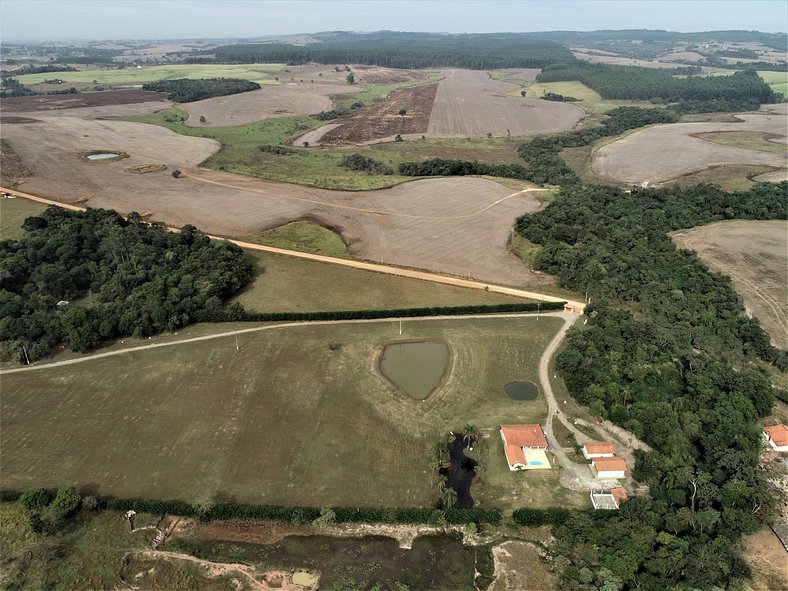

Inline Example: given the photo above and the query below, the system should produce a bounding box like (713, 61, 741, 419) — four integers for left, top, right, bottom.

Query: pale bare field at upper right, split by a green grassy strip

(592, 105, 787, 185)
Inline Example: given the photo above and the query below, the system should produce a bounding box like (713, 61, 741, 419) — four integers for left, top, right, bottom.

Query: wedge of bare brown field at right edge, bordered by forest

(673, 220, 788, 349)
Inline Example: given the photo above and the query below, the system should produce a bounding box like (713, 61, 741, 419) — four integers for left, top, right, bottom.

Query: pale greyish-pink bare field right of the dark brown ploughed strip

(427, 70, 585, 137)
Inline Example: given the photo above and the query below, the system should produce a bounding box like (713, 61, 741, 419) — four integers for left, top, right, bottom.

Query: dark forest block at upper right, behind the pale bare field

(537, 63, 782, 112)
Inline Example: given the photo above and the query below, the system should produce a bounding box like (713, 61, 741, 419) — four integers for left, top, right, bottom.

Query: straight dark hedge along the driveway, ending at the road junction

(195, 302, 566, 322)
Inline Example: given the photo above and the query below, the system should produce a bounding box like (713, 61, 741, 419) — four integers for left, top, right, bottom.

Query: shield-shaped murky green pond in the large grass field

(380, 341, 449, 400)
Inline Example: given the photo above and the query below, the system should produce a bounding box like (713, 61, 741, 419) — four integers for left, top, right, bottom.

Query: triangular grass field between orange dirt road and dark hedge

(233, 252, 523, 312)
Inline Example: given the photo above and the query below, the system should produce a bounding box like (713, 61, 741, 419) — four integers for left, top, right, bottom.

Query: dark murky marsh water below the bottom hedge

(185, 535, 492, 591)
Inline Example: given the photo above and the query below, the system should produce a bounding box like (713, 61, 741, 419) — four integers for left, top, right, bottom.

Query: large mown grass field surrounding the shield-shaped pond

(0, 315, 562, 507)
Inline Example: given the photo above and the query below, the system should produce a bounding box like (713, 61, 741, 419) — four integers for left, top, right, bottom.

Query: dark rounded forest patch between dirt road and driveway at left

(0, 207, 252, 363)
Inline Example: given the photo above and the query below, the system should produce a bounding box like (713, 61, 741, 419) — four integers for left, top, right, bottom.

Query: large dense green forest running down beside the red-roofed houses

(516, 182, 788, 591)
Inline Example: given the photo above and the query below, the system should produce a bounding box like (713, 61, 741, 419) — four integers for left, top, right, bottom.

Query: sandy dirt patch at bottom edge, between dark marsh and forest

(488, 541, 557, 591)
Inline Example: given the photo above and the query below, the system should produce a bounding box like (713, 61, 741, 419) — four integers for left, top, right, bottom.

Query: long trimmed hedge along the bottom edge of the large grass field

(98, 497, 501, 524)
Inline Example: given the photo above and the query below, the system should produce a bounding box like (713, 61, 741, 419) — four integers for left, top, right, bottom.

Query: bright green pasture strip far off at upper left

(17, 64, 286, 85)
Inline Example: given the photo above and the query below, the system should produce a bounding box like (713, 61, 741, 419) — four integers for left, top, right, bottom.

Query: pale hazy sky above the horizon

(0, 0, 788, 41)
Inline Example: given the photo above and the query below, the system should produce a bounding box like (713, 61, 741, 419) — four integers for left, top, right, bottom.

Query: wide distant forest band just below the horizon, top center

(208, 33, 574, 70)
